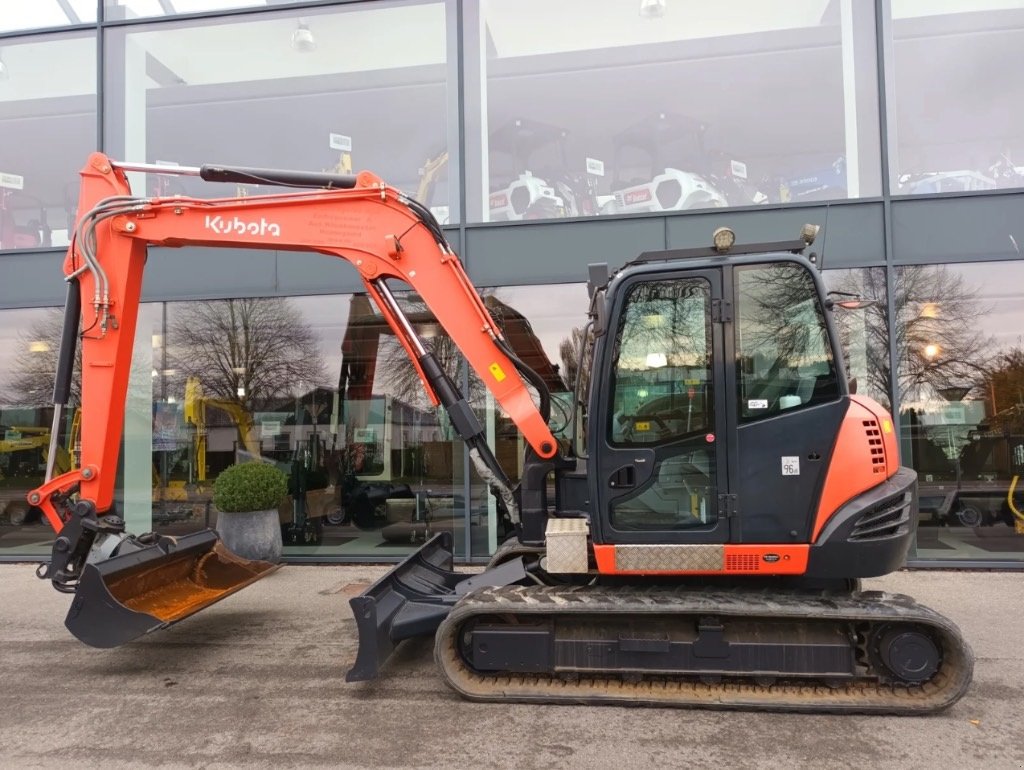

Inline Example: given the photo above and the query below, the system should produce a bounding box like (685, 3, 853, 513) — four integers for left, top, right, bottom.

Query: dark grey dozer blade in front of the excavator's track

(345, 532, 526, 682)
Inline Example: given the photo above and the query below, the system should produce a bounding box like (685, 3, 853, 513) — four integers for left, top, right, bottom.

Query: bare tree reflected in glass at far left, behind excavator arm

(4, 308, 82, 407)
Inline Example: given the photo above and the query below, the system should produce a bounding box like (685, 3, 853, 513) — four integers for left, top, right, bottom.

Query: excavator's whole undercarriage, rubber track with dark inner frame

(434, 586, 974, 715)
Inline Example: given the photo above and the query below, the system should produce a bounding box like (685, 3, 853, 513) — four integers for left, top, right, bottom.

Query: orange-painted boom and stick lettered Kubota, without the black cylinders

(29, 153, 557, 530)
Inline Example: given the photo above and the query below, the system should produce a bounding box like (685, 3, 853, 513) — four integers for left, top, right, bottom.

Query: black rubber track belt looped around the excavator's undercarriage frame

(434, 586, 974, 715)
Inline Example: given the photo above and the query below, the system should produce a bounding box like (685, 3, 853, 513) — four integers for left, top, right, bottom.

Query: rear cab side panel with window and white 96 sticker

(726, 259, 849, 544)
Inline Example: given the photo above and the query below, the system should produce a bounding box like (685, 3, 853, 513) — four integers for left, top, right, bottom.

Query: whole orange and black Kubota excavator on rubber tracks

(29, 154, 973, 714)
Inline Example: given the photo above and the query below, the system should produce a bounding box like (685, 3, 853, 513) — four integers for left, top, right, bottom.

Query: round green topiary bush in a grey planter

(213, 463, 288, 562)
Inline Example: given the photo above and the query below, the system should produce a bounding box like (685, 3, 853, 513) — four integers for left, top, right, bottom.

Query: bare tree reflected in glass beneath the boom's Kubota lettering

(168, 297, 326, 412)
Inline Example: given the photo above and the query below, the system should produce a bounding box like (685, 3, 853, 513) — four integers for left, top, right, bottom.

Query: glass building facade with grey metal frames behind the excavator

(0, 0, 1024, 567)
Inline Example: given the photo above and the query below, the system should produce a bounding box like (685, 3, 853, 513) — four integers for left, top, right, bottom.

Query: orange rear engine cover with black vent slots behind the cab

(811, 395, 899, 543)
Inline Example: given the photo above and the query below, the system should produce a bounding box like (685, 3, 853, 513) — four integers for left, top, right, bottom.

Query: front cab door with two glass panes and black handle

(591, 268, 729, 544)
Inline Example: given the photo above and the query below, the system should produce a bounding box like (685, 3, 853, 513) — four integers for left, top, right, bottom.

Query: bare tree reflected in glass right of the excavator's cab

(829, 265, 990, 402)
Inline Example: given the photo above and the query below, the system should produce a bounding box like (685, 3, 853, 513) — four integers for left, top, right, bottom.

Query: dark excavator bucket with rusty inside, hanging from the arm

(65, 529, 280, 647)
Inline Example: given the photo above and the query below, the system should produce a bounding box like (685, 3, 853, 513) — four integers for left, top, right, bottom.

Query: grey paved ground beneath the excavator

(0, 564, 1024, 770)
